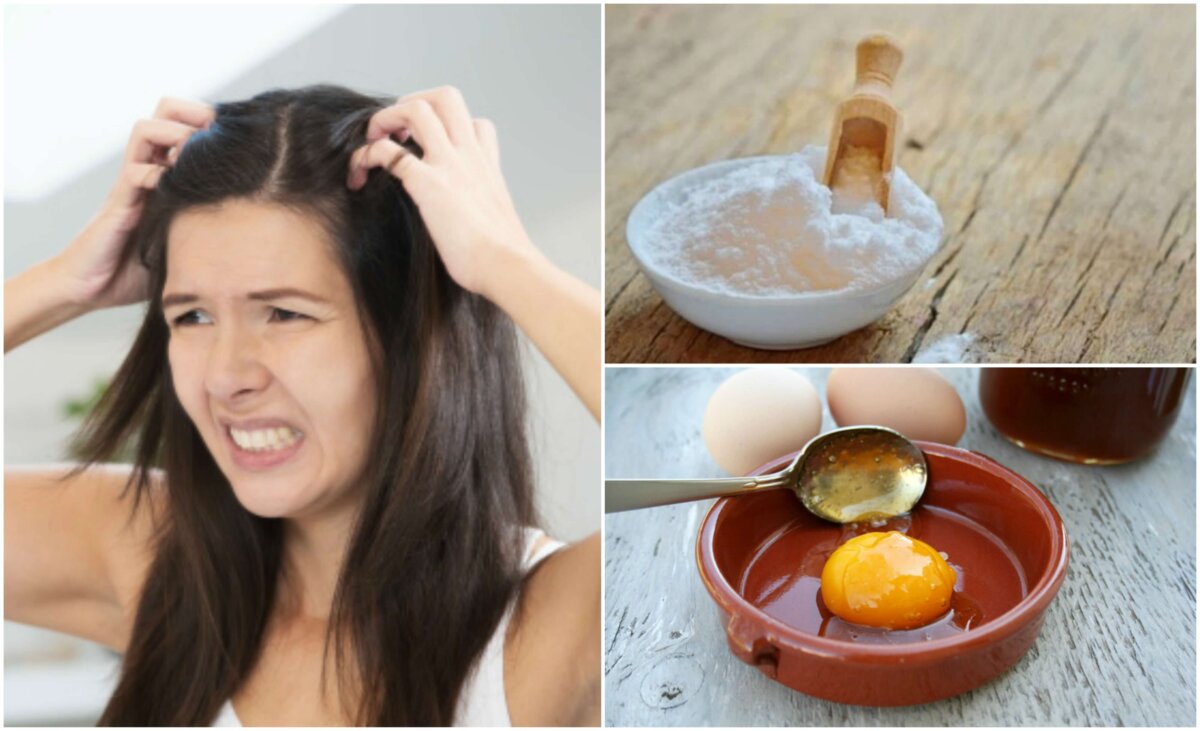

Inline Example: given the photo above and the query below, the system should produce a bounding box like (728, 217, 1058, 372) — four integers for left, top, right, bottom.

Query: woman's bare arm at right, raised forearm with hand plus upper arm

(347, 88, 601, 726)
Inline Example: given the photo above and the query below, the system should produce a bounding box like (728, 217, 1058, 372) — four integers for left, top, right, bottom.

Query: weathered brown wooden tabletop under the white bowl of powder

(605, 5, 1196, 362)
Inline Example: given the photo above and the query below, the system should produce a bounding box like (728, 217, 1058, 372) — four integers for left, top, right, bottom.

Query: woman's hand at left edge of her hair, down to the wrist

(54, 98, 215, 310)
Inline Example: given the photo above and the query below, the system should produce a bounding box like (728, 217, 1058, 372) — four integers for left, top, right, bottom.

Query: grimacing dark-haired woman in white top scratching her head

(5, 86, 600, 725)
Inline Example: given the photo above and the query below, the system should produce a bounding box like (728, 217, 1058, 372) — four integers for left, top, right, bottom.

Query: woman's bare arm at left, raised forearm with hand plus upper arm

(4, 98, 214, 638)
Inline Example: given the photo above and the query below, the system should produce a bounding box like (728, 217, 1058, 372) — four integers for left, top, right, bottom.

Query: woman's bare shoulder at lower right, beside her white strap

(504, 533, 600, 726)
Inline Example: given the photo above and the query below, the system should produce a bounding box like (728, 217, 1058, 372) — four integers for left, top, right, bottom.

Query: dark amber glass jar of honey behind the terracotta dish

(979, 369, 1190, 465)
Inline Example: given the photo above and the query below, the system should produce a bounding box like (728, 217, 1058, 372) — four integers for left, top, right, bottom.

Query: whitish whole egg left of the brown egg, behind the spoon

(704, 367, 821, 477)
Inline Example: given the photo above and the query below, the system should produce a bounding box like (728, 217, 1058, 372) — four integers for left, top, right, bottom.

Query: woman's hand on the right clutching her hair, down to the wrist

(347, 86, 538, 301)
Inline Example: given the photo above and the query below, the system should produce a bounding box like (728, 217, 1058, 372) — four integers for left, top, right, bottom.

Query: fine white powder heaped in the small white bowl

(643, 145, 942, 296)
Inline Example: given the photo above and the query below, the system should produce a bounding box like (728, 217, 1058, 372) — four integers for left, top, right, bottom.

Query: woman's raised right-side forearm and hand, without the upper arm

(347, 88, 601, 420)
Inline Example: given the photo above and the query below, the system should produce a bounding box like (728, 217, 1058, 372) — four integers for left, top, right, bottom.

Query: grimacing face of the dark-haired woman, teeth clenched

(162, 199, 376, 517)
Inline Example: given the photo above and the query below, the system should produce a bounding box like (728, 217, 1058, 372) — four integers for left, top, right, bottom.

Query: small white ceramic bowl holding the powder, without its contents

(625, 157, 924, 350)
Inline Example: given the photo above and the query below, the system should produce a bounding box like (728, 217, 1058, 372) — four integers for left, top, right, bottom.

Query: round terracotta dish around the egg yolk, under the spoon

(696, 442, 1068, 706)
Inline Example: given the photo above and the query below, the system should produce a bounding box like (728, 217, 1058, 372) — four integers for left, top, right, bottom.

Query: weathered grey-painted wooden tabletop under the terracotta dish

(605, 369, 1196, 726)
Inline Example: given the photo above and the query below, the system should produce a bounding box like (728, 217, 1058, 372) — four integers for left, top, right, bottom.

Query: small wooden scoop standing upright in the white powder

(822, 34, 904, 212)
